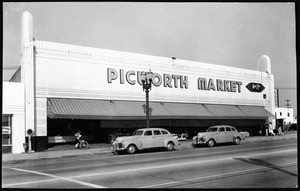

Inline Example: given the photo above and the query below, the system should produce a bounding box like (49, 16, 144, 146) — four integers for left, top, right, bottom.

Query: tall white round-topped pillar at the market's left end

(21, 12, 35, 132)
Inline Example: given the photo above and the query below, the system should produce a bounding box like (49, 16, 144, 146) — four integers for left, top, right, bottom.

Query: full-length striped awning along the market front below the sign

(47, 98, 272, 120)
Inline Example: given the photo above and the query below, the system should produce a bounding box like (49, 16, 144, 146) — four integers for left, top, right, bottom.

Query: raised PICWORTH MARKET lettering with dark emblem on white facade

(107, 68, 263, 93)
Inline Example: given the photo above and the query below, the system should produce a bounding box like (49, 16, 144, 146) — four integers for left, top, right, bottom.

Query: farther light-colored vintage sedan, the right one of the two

(192, 125, 245, 147)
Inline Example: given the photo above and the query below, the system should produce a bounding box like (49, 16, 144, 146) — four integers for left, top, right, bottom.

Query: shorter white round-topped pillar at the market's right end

(258, 55, 275, 128)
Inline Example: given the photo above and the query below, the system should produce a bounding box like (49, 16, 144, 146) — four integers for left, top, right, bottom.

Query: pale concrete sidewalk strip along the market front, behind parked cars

(2, 131, 297, 163)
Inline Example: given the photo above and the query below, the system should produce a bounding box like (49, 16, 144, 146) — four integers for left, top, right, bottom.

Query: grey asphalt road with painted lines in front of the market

(2, 139, 298, 188)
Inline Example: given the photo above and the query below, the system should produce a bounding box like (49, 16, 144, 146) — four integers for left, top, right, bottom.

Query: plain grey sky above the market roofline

(3, 2, 297, 115)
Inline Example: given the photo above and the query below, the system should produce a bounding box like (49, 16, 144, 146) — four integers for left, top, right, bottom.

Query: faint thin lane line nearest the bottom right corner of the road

(139, 162, 297, 188)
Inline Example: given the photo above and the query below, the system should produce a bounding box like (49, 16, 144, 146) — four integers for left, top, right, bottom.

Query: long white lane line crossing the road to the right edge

(3, 149, 297, 186)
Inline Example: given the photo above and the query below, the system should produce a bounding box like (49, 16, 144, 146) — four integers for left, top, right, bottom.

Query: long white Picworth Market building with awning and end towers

(4, 12, 275, 152)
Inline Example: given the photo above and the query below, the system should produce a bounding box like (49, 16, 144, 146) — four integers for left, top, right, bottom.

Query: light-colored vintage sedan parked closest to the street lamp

(111, 128, 179, 154)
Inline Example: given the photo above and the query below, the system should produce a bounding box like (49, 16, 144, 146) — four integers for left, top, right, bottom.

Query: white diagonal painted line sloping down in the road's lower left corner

(2, 168, 106, 188)
